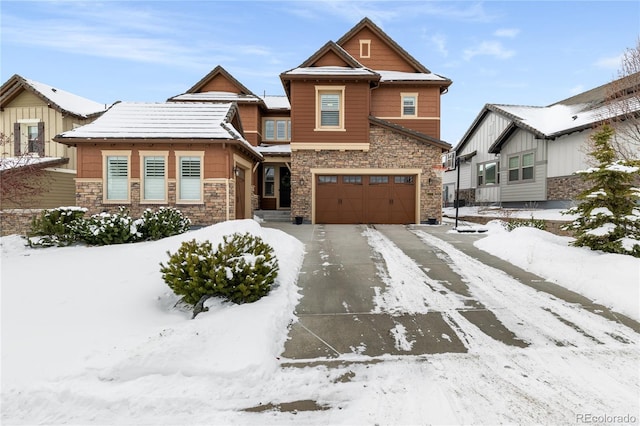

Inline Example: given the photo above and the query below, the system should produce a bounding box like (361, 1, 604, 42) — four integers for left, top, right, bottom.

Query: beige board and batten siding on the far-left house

(0, 91, 92, 170)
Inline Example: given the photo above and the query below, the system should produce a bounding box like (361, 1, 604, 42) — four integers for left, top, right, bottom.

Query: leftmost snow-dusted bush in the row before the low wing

(26, 207, 87, 247)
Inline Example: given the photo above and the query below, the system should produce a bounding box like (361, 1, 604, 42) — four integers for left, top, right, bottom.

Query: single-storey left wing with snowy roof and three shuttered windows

(54, 102, 262, 225)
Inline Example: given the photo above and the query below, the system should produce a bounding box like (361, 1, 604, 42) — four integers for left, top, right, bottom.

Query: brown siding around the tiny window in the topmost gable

(342, 28, 415, 72)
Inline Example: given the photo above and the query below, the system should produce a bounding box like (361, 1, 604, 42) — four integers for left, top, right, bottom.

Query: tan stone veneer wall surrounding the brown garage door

(291, 126, 442, 221)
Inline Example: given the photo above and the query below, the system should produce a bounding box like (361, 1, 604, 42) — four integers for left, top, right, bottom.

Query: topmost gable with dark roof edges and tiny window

(337, 18, 431, 74)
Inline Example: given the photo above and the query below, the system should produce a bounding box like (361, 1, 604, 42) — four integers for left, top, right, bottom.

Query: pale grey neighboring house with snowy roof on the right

(443, 73, 640, 208)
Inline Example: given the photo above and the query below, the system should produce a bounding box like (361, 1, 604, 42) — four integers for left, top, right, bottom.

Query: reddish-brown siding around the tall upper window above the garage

(291, 81, 370, 143)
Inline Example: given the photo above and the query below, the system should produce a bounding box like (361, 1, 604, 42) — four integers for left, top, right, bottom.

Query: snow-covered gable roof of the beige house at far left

(0, 74, 107, 119)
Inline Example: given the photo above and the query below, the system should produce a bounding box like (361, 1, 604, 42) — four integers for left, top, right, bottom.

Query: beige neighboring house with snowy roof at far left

(0, 75, 106, 209)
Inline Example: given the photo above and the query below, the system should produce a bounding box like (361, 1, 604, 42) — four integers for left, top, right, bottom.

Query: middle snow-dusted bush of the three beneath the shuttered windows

(72, 207, 142, 246)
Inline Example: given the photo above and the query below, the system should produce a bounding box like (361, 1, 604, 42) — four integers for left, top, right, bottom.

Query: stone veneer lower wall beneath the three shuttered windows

(76, 180, 236, 226)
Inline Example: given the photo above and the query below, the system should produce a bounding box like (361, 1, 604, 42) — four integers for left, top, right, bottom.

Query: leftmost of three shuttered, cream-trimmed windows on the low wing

(102, 151, 131, 203)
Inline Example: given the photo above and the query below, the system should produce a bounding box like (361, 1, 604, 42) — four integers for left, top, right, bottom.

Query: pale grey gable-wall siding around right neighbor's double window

(500, 129, 547, 202)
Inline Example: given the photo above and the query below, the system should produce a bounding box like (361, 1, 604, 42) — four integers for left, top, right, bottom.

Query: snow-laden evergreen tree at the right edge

(564, 126, 640, 257)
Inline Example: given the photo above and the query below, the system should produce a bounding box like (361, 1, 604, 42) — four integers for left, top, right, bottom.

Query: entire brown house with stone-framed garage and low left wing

(55, 18, 451, 225)
